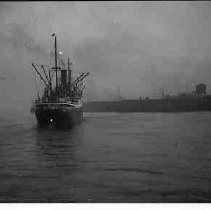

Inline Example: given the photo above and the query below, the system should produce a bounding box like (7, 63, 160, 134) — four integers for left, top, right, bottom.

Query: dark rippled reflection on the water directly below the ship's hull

(36, 127, 81, 171)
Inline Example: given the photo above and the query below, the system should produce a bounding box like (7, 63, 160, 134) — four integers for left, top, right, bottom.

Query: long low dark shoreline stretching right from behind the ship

(84, 97, 211, 113)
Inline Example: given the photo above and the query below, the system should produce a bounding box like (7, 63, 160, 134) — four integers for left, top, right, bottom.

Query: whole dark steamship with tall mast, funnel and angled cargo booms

(31, 33, 90, 128)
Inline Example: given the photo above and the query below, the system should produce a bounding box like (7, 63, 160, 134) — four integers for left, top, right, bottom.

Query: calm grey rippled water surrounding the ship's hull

(0, 112, 211, 202)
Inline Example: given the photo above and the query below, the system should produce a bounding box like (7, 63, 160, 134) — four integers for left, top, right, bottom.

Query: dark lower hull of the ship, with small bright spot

(35, 108, 83, 127)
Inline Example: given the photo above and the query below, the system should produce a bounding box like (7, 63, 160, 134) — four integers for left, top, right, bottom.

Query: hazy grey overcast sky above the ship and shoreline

(0, 1, 211, 113)
